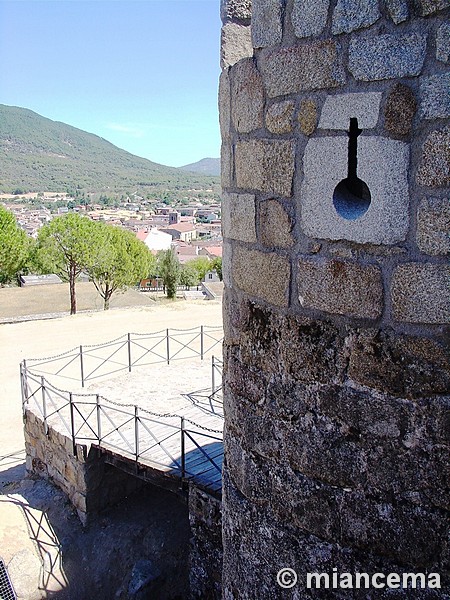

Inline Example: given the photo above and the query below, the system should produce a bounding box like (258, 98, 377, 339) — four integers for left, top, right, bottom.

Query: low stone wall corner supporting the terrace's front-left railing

(24, 410, 144, 525)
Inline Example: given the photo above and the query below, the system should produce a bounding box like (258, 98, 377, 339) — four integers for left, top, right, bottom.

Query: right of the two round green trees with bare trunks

(86, 223, 156, 310)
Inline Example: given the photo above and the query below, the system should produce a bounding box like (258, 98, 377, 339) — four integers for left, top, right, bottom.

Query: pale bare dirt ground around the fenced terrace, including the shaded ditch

(0, 284, 222, 600)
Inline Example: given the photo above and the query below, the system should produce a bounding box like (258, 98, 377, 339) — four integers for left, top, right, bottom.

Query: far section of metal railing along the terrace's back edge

(23, 325, 223, 387)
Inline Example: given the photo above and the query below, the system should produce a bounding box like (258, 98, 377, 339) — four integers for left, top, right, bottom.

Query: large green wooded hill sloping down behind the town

(0, 104, 219, 194)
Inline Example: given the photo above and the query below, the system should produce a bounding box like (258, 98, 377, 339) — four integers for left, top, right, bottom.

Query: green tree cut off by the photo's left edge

(0, 206, 30, 285)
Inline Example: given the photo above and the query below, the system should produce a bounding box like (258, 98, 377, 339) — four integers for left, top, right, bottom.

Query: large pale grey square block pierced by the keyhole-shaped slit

(300, 136, 409, 244)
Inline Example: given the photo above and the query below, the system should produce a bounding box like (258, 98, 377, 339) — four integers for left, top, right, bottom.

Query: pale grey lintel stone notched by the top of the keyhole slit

(319, 92, 383, 131)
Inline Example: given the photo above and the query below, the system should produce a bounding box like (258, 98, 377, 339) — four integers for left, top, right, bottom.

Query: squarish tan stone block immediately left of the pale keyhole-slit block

(235, 140, 294, 196)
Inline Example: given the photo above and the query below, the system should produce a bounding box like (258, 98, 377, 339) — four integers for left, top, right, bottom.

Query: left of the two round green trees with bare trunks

(36, 213, 98, 315)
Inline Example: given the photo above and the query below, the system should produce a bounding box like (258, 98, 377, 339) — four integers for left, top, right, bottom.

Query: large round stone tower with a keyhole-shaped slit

(219, 0, 450, 600)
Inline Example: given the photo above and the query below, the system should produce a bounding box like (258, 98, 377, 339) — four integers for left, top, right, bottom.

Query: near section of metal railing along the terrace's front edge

(20, 363, 222, 487)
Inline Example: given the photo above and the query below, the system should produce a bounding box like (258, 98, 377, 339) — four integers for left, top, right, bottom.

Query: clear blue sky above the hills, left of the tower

(0, 0, 221, 166)
